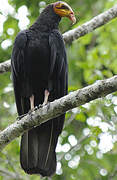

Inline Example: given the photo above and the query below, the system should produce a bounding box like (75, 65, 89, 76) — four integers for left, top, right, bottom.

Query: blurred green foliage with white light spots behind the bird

(0, 0, 117, 180)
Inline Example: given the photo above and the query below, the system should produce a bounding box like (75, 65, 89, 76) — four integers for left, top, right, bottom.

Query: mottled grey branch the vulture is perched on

(0, 76, 117, 150)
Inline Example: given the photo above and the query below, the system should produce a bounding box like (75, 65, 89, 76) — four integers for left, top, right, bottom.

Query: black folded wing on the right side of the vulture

(49, 30, 68, 98)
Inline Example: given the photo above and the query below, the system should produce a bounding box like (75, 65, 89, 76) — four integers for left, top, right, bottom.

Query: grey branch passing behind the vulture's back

(0, 5, 117, 73)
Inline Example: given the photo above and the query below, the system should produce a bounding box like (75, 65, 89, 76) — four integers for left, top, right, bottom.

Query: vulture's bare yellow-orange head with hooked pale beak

(53, 1, 76, 24)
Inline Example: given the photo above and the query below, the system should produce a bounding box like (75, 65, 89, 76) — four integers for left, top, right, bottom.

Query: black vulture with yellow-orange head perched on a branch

(11, 1, 76, 176)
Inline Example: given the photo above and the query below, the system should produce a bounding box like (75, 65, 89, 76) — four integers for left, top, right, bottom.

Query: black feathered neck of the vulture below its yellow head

(30, 5, 61, 32)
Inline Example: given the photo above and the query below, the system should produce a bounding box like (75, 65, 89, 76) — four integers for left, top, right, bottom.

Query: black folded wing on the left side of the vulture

(11, 31, 27, 115)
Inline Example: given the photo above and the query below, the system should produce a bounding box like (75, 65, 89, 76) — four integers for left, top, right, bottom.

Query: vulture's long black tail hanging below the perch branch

(20, 115, 64, 176)
